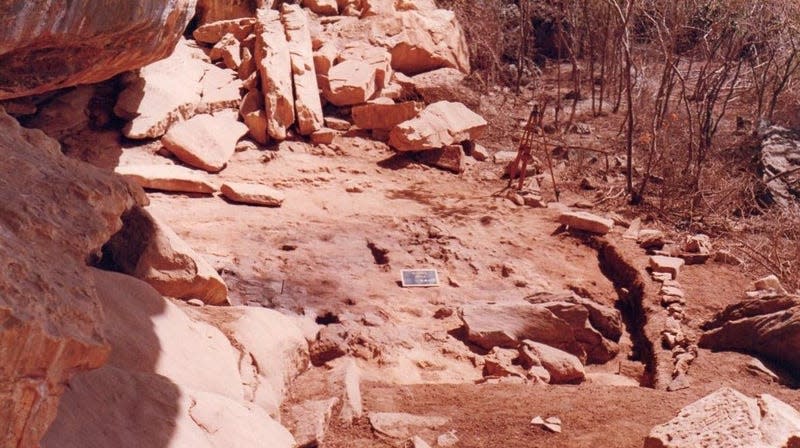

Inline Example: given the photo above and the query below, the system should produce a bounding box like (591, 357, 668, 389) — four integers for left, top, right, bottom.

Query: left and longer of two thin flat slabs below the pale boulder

(114, 165, 217, 194)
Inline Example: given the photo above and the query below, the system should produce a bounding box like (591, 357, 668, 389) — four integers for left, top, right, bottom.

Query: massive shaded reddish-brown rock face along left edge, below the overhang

(0, 109, 146, 447)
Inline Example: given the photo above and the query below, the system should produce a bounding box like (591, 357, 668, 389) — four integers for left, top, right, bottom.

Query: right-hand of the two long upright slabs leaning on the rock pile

(281, 4, 323, 135)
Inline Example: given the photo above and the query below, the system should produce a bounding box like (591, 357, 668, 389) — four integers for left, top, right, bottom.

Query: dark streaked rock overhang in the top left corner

(0, 0, 195, 100)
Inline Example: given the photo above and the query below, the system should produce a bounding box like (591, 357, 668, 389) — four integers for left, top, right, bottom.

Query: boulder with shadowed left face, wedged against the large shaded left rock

(103, 208, 228, 305)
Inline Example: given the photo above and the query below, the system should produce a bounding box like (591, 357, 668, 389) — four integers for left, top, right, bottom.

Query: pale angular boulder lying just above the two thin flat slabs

(161, 114, 248, 173)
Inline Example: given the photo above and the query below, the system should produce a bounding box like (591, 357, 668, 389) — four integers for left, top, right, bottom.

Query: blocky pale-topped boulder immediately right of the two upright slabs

(323, 60, 375, 106)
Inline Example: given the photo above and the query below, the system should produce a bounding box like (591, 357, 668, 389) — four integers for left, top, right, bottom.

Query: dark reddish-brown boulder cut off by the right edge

(700, 296, 800, 372)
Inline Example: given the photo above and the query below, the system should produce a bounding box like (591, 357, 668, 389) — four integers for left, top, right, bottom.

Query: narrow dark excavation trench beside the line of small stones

(585, 237, 658, 388)
